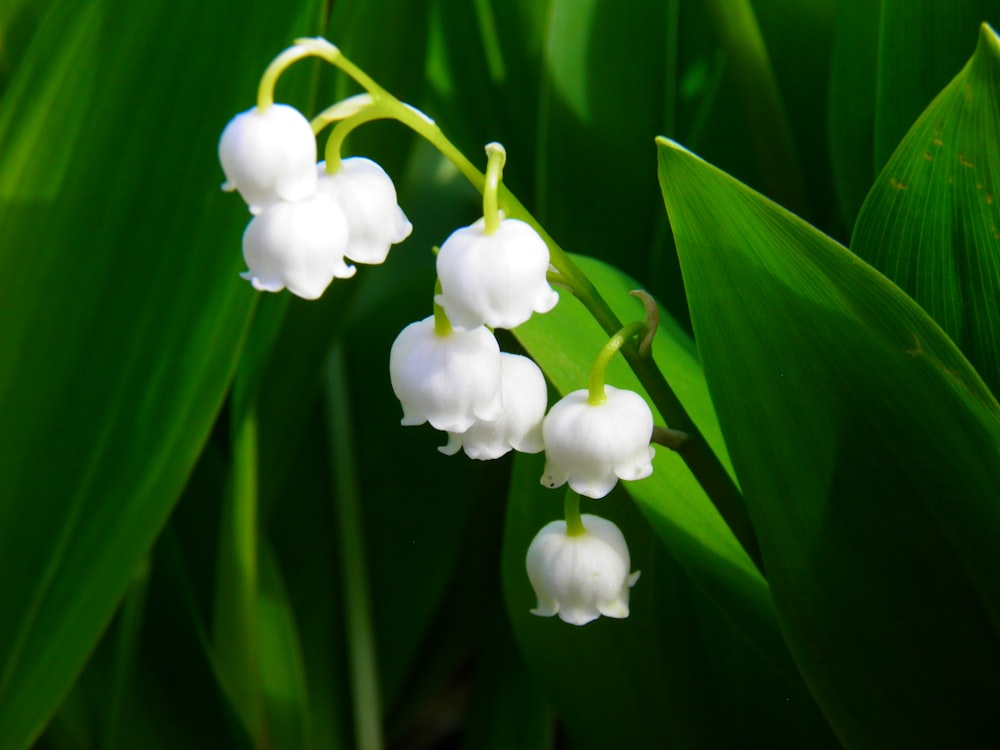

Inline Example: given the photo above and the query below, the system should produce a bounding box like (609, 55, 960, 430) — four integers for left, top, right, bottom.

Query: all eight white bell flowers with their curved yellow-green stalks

(219, 39, 655, 625)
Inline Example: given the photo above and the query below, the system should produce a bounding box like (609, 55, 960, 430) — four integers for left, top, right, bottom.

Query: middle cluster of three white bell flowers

(389, 212, 558, 460)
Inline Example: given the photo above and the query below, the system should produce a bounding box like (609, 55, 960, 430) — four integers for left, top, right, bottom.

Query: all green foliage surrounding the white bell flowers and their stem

(0, 0, 1000, 750)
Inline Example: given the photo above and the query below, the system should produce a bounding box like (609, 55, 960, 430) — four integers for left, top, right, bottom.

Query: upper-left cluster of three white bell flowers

(219, 104, 412, 299)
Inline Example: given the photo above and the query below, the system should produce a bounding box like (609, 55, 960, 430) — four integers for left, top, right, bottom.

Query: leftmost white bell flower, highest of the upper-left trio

(219, 104, 316, 214)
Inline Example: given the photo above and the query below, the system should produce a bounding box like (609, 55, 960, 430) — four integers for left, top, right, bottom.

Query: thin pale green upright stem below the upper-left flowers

(326, 342, 384, 750)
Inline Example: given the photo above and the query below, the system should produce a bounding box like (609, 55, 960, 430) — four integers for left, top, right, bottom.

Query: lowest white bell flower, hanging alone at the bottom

(525, 513, 639, 625)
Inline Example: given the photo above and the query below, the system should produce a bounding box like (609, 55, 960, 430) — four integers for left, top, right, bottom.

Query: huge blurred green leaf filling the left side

(0, 0, 316, 750)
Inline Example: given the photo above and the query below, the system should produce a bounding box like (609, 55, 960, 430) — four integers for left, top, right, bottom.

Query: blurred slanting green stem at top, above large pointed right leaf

(707, 0, 809, 218)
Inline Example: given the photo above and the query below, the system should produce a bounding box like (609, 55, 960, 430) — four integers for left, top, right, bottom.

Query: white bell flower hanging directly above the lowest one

(542, 385, 654, 498)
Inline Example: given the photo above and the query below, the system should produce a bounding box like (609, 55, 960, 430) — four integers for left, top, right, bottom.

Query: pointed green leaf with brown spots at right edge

(851, 24, 1000, 394)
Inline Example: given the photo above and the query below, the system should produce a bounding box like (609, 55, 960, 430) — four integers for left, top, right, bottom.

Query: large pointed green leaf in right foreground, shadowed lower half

(659, 140, 1000, 747)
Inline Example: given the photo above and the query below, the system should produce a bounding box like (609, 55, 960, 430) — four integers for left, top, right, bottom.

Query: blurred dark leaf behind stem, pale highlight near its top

(540, 0, 678, 284)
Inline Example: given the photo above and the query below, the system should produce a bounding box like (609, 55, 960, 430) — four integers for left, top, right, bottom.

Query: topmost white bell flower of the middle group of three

(437, 219, 559, 328)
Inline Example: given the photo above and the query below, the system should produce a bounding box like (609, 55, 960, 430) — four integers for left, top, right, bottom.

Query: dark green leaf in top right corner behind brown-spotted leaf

(875, 0, 1000, 170)
